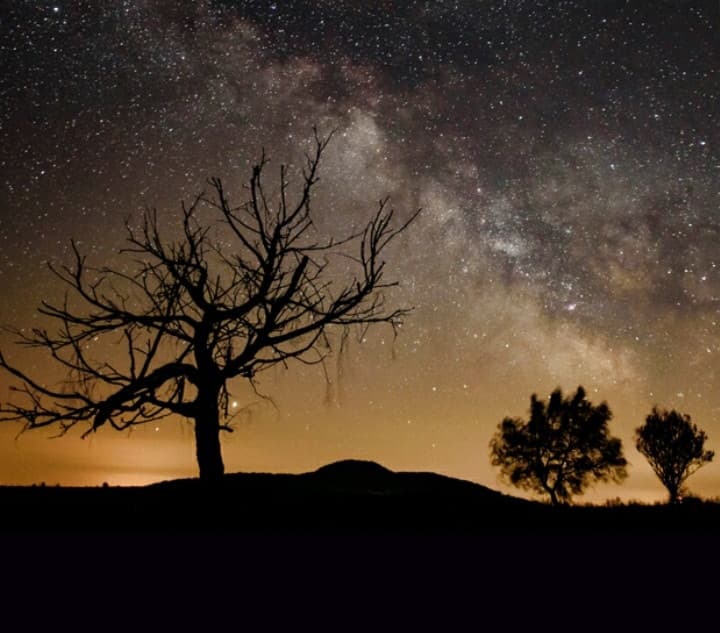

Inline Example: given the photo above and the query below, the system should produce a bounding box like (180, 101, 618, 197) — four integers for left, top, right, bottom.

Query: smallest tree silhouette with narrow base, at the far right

(635, 407, 715, 503)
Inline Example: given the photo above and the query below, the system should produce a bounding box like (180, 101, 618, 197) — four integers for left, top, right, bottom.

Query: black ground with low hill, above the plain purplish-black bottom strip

(0, 461, 720, 538)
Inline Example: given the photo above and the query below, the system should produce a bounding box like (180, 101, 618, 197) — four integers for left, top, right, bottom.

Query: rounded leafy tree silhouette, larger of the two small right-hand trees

(490, 387, 627, 505)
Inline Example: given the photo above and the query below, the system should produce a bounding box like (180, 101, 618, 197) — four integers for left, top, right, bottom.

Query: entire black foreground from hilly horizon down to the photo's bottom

(0, 462, 720, 620)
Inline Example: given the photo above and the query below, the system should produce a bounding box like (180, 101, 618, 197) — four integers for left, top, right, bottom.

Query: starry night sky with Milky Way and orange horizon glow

(0, 0, 720, 501)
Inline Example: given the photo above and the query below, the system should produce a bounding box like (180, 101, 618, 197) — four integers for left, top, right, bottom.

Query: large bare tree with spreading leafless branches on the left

(0, 131, 419, 480)
